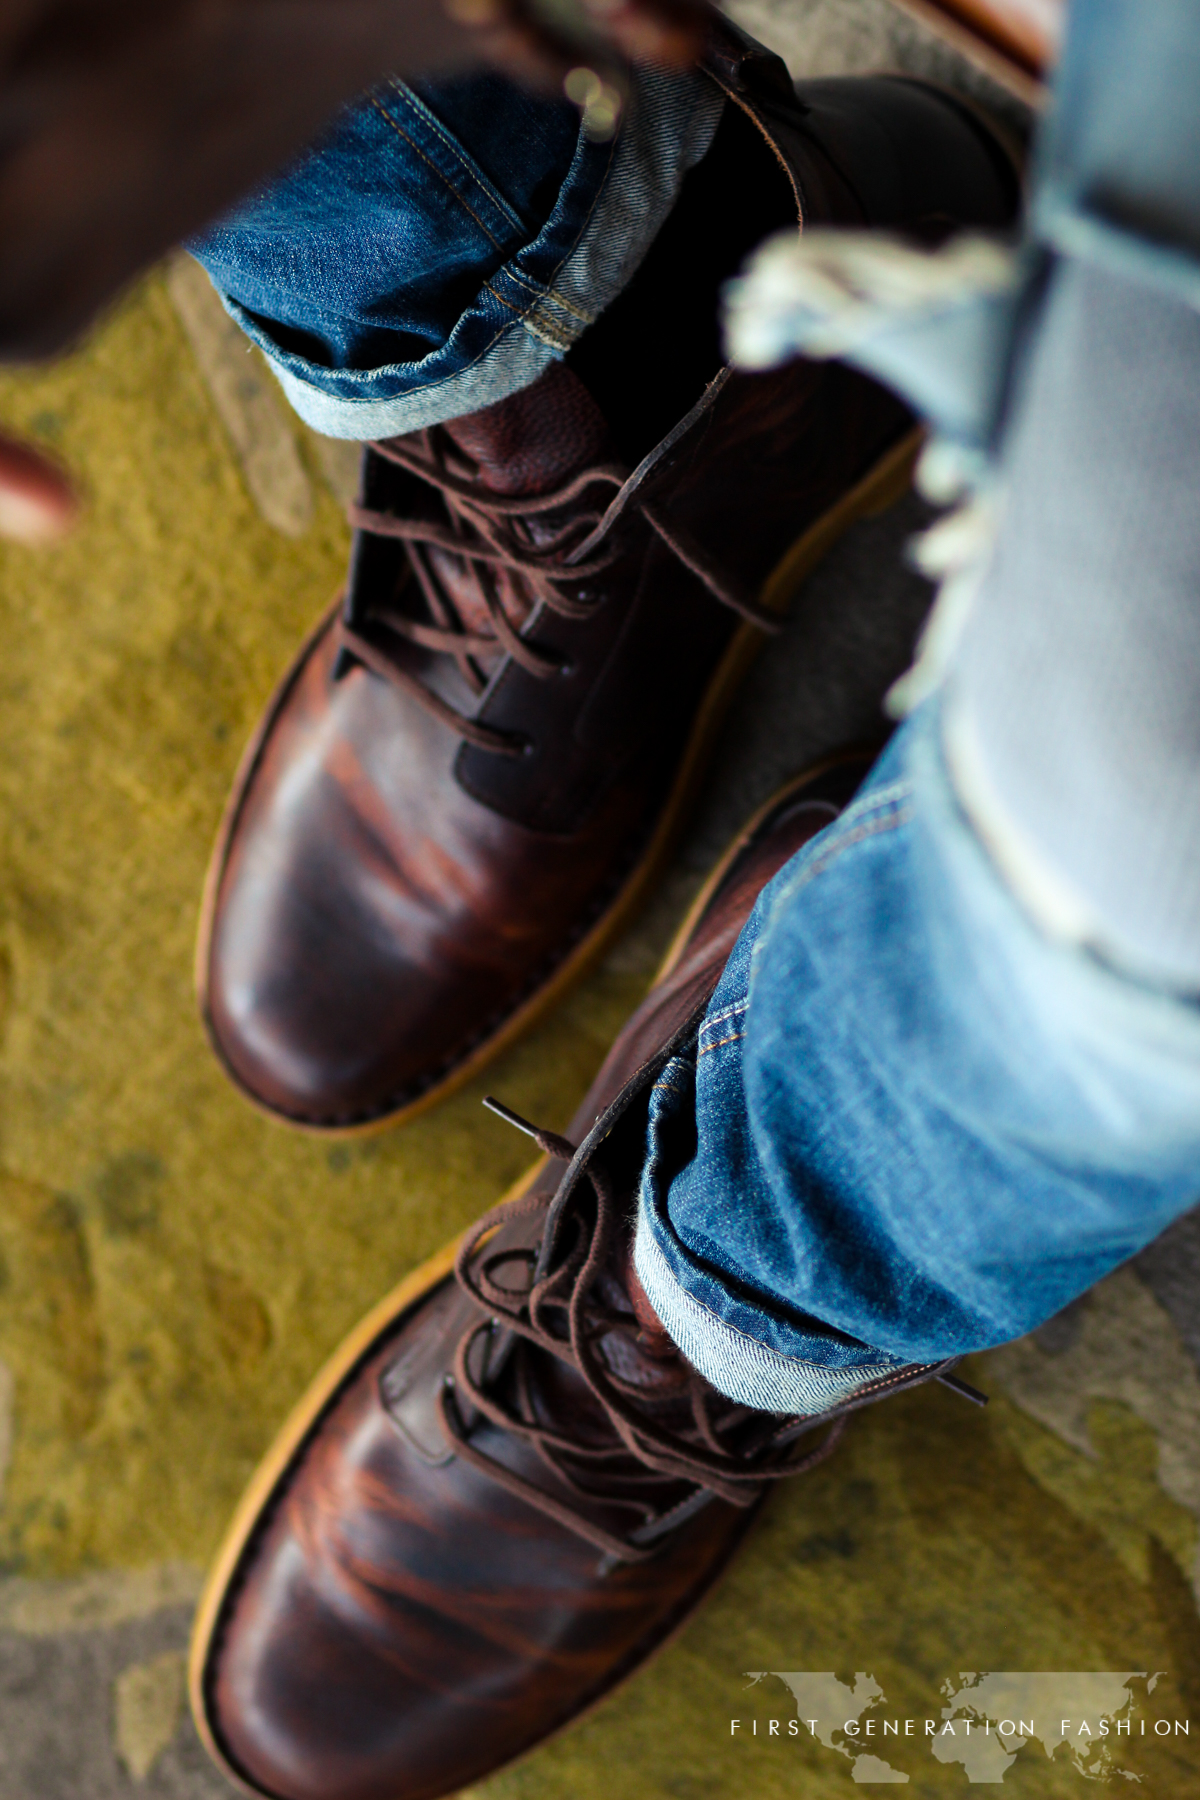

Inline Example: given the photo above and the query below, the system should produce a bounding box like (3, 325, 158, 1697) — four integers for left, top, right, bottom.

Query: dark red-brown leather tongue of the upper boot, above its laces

(443, 362, 613, 497)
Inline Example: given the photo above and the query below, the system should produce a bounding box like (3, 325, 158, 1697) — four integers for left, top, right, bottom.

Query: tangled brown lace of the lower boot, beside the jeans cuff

(439, 1105, 846, 1562)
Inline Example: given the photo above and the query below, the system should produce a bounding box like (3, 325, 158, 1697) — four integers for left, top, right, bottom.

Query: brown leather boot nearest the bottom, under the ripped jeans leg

(191, 758, 978, 1800)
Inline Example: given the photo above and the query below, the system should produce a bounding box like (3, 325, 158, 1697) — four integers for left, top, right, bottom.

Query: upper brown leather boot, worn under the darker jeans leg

(198, 24, 1016, 1130)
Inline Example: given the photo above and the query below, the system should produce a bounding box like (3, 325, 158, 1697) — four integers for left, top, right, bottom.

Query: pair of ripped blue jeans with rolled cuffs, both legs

(194, 0, 1200, 1411)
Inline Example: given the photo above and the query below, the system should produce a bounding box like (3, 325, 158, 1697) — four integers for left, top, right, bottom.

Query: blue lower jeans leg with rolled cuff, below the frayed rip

(635, 700, 1200, 1411)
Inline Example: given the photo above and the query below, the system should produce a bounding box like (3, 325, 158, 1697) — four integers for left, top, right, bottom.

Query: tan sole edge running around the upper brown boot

(196, 428, 923, 1141)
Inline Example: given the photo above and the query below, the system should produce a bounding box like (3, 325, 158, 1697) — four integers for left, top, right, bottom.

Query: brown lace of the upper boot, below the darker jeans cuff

(338, 428, 781, 756)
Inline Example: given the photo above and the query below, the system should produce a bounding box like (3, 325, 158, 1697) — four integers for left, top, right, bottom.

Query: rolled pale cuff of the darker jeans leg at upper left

(237, 68, 725, 441)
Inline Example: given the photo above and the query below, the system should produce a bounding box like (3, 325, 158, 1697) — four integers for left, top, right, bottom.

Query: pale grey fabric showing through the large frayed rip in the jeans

(946, 250, 1200, 992)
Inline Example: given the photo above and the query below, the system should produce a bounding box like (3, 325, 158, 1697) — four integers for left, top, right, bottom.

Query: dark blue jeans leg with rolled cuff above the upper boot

(189, 72, 723, 439)
